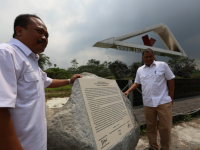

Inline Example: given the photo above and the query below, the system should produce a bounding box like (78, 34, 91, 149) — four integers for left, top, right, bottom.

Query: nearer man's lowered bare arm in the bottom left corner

(0, 108, 23, 150)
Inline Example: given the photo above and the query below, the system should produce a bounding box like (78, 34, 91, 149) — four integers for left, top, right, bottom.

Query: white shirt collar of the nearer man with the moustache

(9, 38, 35, 57)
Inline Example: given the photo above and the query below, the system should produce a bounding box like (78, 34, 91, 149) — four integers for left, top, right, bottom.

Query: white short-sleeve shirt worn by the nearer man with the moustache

(0, 38, 52, 150)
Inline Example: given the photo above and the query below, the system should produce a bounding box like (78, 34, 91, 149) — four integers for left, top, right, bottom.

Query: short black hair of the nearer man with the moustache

(13, 14, 42, 38)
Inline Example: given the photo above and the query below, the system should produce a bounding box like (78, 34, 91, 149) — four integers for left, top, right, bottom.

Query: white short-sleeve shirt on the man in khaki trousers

(135, 61, 175, 107)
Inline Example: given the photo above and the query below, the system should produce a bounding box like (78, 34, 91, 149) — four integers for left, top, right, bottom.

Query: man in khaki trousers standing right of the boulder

(124, 49, 175, 150)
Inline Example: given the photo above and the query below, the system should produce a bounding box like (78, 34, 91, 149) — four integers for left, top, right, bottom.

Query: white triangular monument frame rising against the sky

(93, 23, 187, 57)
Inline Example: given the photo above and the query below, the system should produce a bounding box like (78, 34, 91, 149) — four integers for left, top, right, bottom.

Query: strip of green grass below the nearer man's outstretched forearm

(45, 85, 72, 100)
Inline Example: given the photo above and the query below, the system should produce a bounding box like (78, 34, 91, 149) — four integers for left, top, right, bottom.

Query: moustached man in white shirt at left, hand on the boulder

(0, 14, 81, 150)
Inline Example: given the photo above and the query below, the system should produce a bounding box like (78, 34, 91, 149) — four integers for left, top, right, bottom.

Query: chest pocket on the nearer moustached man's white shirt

(24, 72, 39, 100)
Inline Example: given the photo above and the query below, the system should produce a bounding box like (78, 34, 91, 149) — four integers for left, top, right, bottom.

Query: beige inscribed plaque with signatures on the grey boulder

(79, 79, 133, 150)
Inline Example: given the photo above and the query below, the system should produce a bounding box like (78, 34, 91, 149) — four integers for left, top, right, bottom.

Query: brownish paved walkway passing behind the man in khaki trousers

(133, 96, 200, 125)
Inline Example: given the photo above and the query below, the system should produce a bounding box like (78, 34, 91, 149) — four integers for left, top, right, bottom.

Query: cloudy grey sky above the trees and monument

(0, 0, 200, 69)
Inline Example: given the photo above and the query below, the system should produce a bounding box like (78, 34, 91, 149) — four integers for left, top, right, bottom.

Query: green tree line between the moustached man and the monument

(38, 54, 112, 79)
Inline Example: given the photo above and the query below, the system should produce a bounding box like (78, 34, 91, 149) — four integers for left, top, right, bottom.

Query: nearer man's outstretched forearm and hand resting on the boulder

(47, 74, 82, 88)
